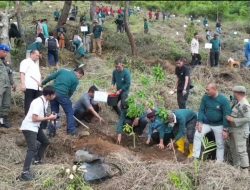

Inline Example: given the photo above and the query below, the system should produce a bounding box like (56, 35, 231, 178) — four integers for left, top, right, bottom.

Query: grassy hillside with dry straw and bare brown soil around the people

(0, 1, 250, 190)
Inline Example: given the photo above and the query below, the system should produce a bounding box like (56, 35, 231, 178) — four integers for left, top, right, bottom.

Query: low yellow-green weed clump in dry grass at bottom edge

(168, 171, 194, 190)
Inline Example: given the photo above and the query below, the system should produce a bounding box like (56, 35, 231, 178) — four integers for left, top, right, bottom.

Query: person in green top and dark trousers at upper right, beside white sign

(210, 33, 221, 67)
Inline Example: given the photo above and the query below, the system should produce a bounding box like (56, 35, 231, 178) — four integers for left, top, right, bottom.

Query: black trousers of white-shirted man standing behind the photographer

(24, 89, 42, 115)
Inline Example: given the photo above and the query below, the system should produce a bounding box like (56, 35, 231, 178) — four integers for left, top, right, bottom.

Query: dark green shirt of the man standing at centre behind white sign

(112, 69, 131, 92)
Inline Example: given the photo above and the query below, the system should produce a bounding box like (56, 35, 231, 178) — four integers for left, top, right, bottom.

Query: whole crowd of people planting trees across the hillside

(0, 2, 250, 181)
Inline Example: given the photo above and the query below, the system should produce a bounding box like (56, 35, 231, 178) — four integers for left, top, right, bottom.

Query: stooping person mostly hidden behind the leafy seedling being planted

(116, 102, 148, 144)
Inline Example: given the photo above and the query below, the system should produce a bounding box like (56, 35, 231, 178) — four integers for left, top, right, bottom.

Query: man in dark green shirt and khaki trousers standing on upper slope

(92, 20, 103, 55)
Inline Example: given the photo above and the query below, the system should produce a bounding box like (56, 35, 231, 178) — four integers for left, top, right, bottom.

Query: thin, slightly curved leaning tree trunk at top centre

(124, 1, 137, 56)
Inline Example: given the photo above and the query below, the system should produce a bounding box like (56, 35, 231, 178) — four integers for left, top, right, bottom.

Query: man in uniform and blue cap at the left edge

(0, 44, 16, 128)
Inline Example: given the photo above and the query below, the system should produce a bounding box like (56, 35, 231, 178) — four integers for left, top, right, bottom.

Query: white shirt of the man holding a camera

(20, 96, 48, 133)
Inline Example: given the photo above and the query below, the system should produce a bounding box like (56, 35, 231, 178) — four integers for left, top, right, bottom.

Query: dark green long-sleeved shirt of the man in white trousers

(198, 94, 231, 128)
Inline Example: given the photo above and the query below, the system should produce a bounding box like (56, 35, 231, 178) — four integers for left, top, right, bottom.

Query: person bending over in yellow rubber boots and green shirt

(168, 109, 197, 158)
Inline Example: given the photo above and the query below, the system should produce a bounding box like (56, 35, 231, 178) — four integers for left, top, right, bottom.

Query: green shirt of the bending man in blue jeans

(42, 69, 79, 97)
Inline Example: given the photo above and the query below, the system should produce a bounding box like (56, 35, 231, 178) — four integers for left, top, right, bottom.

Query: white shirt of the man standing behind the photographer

(20, 58, 41, 90)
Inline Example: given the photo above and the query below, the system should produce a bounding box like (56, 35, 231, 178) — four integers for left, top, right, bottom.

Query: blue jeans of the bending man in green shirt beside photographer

(50, 94, 76, 133)
